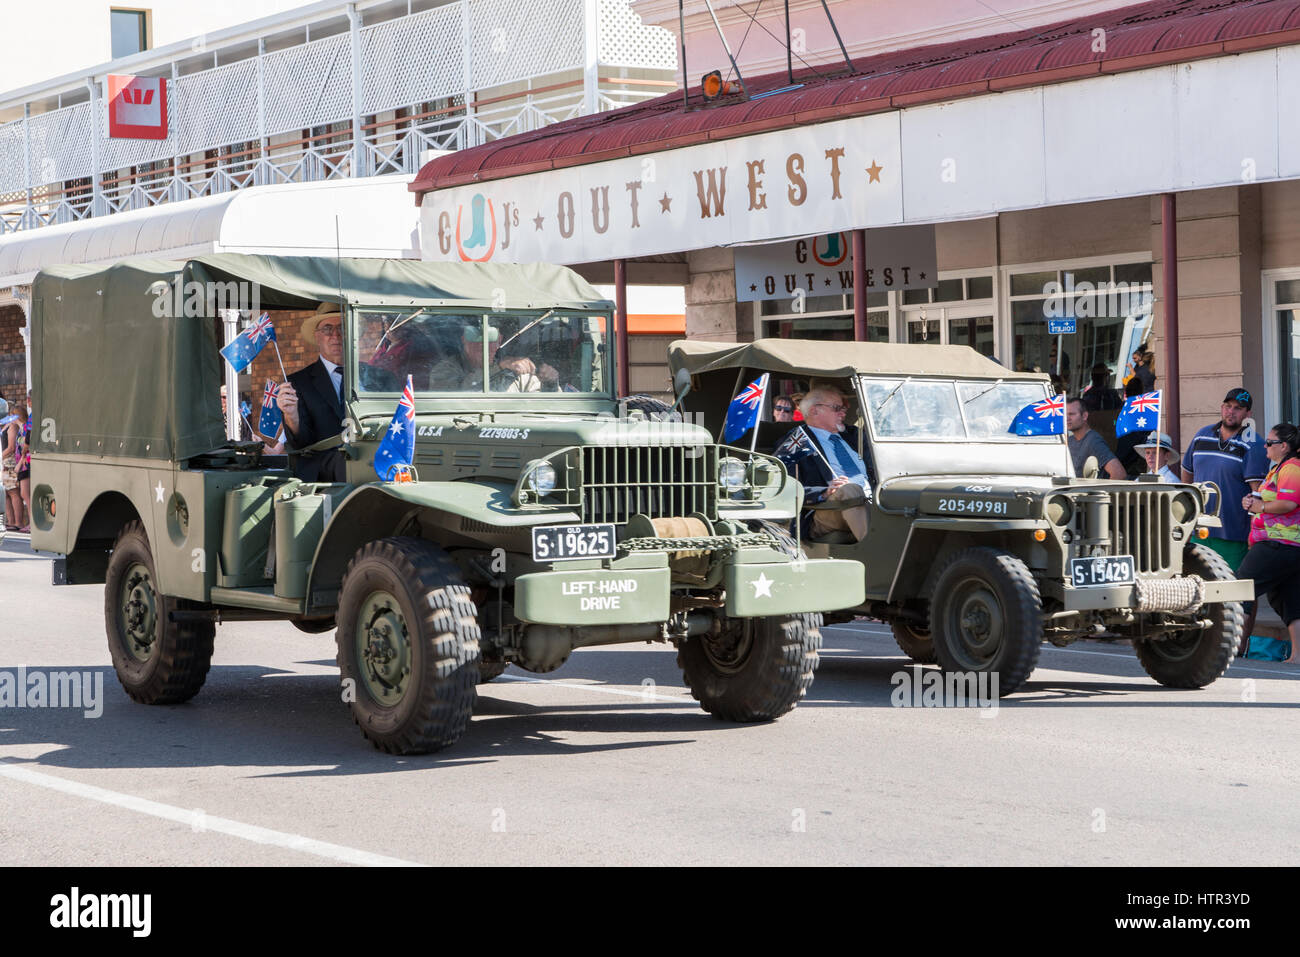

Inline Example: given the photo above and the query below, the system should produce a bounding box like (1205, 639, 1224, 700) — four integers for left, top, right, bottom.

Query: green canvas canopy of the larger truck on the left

(31, 254, 608, 460)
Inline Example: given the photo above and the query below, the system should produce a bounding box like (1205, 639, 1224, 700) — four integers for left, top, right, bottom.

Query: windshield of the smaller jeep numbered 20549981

(861, 376, 1061, 443)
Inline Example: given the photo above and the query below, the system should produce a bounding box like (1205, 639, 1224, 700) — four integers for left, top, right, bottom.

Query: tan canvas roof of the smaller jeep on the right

(668, 338, 1048, 381)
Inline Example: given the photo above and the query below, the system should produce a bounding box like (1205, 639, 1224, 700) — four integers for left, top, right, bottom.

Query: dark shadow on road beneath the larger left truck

(0, 666, 742, 776)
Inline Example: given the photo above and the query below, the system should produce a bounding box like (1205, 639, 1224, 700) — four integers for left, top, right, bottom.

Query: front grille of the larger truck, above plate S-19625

(582, 446, 718, 524)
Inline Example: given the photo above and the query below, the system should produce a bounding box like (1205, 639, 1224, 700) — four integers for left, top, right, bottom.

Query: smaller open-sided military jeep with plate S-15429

(670, 339, 1253, 694)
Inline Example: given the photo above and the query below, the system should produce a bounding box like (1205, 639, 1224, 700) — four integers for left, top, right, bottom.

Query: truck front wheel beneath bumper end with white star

(677, 615, 822, 722)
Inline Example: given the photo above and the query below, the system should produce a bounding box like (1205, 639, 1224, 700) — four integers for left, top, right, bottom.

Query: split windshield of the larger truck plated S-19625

(354, 308, 610, 395)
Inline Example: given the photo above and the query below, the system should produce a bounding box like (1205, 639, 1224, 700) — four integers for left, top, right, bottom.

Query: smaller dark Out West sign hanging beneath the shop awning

(736, 226, 939, 303)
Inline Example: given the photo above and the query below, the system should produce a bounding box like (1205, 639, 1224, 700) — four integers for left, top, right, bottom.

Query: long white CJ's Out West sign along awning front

(420, 114, 904, 267)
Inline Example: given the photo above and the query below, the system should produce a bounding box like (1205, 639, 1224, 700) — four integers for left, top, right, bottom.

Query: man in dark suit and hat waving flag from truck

(280, 303, 345, 482)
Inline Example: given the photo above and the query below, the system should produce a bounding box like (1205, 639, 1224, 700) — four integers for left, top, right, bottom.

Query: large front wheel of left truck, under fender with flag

(338, 538, 480, 754)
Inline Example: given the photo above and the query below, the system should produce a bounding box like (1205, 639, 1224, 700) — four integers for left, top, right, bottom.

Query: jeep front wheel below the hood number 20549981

(930, 547, 1043, 694)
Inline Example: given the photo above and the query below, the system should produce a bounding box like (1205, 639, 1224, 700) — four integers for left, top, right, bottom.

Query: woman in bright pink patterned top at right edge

(1236, 424, 1300, 664)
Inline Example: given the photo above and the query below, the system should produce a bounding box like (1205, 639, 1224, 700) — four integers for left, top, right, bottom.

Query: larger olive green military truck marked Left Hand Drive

(31, 254, 862, 753)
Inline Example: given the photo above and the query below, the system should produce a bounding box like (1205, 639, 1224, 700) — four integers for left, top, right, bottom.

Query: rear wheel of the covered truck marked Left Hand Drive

(104, 521, 217, 705)
